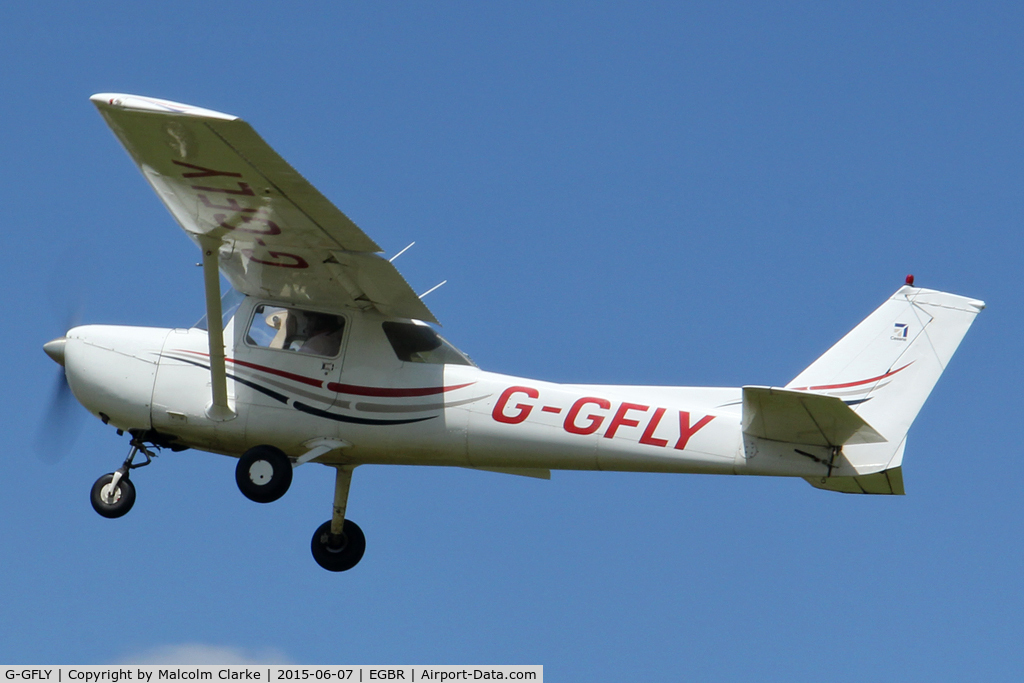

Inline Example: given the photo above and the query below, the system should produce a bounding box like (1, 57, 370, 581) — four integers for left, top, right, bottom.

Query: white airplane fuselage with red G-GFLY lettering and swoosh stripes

(56, 297, 826, 476)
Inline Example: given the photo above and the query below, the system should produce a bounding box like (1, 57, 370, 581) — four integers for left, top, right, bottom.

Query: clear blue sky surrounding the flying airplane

(0, 1, 1024, 681)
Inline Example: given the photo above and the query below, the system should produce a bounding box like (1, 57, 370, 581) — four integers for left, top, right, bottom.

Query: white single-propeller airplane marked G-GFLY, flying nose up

(44, 93, 985, 571)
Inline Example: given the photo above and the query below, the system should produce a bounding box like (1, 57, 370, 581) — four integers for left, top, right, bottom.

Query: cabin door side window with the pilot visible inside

(246, 304, 345, 357)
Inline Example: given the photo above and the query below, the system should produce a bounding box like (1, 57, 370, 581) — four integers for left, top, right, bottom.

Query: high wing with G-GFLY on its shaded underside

(91, 93, 437, 323)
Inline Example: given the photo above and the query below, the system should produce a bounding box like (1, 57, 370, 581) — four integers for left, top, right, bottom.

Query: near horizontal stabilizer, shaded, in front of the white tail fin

(743, 386, 886, 446)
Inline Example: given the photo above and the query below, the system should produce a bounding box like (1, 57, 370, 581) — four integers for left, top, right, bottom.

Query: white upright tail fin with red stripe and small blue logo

(786, 285, 985, 485)
